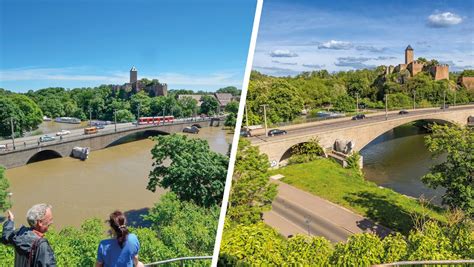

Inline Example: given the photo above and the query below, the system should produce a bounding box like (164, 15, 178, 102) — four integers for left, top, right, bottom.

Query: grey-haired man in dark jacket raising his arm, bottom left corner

(0, 204, 56, 267)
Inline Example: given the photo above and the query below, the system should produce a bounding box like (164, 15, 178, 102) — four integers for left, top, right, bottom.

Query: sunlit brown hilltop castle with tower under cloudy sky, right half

(386, 45, 449, 80)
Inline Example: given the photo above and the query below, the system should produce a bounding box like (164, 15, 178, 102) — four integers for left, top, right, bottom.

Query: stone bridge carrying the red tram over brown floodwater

(0, 118, 219, 169)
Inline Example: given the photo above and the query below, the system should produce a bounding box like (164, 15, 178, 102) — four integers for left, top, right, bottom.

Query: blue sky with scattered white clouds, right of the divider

(253, 0, 474, 76)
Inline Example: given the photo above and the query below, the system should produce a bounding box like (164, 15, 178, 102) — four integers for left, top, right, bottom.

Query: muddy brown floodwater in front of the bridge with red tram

(5, 127, 233, 228)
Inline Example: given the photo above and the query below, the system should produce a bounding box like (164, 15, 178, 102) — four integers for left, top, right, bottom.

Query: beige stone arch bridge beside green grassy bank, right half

(251, 105, 474, 167)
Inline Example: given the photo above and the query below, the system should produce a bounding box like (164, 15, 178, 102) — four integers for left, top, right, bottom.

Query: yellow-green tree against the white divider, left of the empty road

(227, 139, 277, 224)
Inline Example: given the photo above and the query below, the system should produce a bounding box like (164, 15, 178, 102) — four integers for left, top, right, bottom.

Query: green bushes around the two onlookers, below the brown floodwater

(0, 193, 219, 266)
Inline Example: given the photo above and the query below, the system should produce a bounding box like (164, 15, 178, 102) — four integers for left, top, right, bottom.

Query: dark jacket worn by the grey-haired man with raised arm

(0, 220, 56, 267)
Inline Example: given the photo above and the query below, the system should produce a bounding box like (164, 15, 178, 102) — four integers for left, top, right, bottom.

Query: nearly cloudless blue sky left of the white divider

(0, 0, 256, 92)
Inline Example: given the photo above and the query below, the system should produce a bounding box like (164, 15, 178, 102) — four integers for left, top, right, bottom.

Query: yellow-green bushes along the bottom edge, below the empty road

(219, 220, 474, 266)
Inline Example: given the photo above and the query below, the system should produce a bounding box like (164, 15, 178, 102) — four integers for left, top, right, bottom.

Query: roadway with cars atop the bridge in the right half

(249, 105, 474, 144)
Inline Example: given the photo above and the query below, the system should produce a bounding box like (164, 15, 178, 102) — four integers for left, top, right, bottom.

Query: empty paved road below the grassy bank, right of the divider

(263, 181, 391, 243)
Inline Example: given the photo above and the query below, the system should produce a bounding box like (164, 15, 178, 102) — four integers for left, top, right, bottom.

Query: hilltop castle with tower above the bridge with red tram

(112, 67, 168, 96)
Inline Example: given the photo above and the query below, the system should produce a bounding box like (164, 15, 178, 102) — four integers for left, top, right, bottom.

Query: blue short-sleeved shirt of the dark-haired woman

(97, 234, 140, 267)
